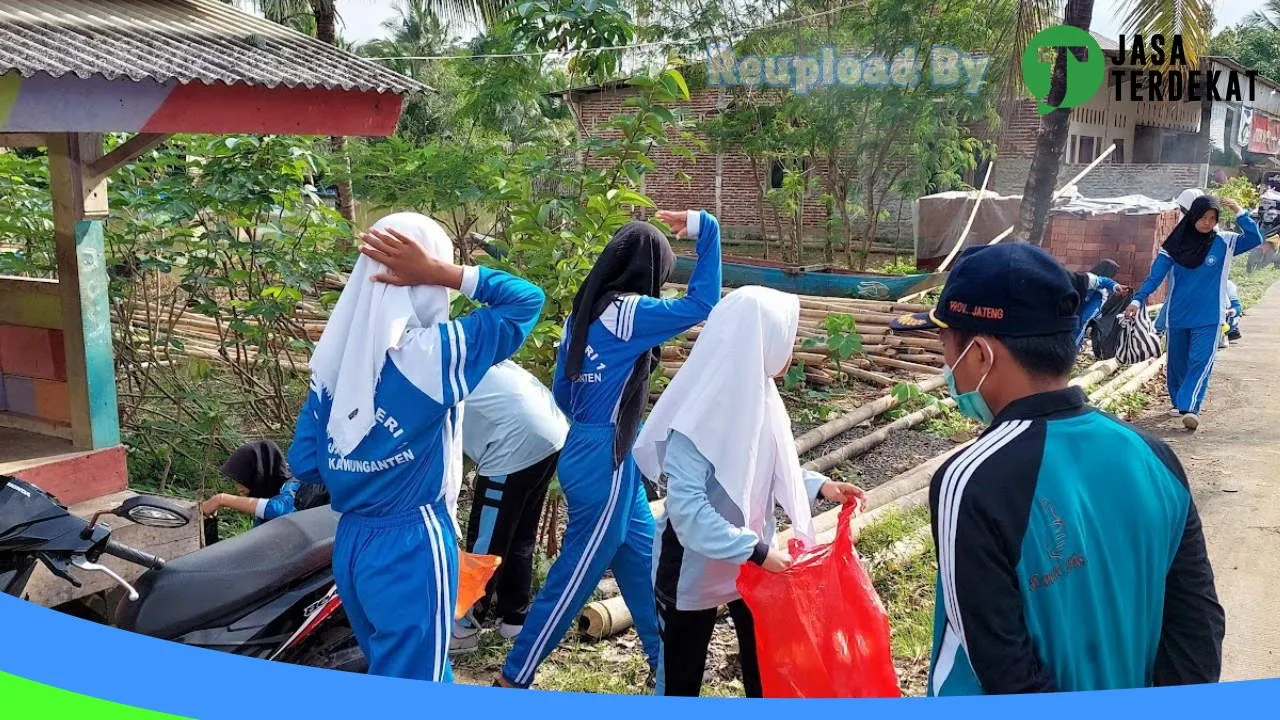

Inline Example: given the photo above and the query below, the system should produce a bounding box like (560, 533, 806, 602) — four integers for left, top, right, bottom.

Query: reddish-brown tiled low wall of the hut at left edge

(0, 324, 70, 425)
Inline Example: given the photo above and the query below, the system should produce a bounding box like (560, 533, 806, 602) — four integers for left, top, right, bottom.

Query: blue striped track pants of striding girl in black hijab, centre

(502, 423, 660, 688)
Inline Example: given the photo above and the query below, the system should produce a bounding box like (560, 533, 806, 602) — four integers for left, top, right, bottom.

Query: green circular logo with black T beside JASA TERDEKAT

(1023, 26, 1106, 115)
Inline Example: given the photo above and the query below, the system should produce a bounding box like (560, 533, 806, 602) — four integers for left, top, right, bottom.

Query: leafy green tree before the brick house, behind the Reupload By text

(705, 0, 988, 265)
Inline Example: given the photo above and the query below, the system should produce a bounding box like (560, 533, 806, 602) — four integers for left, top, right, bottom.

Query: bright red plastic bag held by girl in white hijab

(737, 505, 901, 698)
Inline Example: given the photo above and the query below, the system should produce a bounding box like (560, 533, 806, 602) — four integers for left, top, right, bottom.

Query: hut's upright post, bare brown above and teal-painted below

(49, 133, 120, 450)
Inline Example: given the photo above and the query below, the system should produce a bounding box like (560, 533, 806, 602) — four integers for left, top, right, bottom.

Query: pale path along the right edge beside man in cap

(1140, 284, 1280, 680)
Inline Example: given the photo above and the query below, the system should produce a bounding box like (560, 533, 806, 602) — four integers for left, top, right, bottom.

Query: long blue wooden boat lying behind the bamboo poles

(671, 255, 947, 300)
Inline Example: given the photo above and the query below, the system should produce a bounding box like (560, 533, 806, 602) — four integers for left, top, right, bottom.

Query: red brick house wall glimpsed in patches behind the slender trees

(572, 87, 913, 242)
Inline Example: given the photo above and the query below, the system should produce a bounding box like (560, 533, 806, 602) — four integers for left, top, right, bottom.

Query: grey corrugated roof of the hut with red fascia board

(0, 0, 426, 94)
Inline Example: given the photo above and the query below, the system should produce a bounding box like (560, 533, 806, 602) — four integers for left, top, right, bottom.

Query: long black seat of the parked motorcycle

(116, 505, 339, 639)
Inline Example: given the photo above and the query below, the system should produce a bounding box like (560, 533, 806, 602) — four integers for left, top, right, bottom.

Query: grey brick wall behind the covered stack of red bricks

(991, 155, 1208, 200)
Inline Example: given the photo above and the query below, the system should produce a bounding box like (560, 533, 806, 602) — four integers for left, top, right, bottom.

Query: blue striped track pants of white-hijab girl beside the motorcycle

(333, 502, 458, 683)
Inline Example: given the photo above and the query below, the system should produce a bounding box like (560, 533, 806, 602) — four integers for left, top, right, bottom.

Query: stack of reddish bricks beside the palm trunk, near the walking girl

(1044, 210, 1180, 304)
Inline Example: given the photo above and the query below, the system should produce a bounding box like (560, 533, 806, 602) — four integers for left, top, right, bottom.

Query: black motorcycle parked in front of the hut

(0, 475, 367, 673)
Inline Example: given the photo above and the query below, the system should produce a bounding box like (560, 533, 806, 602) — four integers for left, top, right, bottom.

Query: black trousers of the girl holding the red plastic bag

(658, 600, 764, 697)
